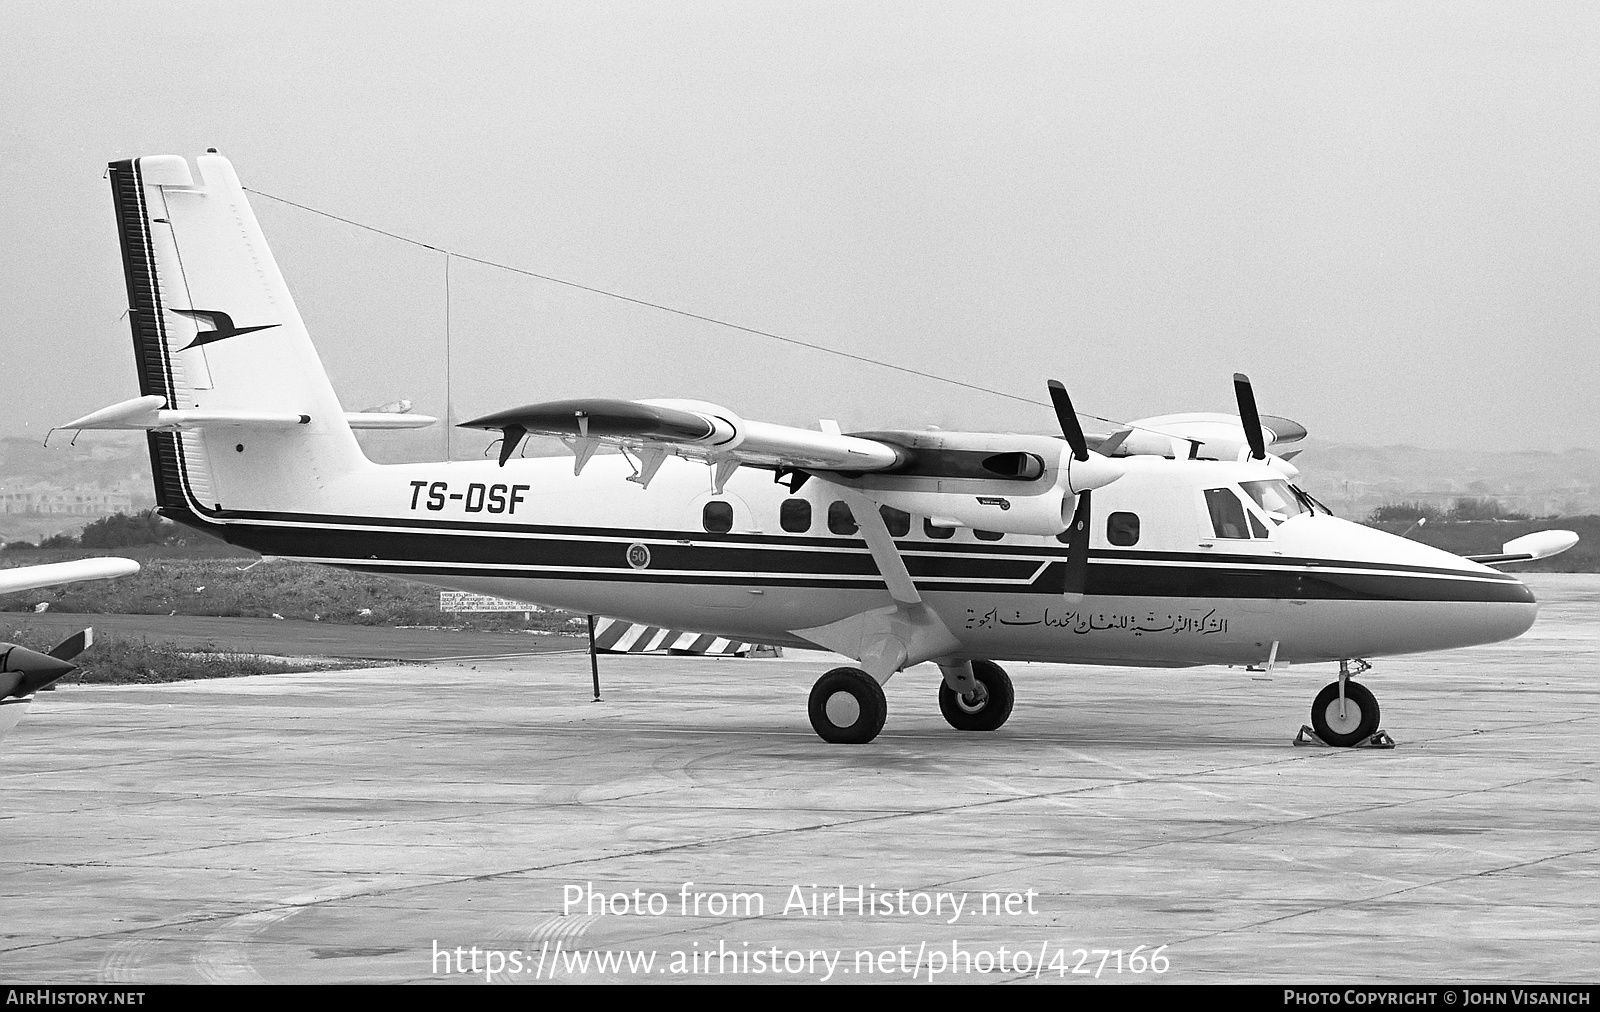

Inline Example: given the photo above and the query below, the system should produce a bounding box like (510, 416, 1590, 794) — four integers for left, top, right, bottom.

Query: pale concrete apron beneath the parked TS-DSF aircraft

(0, 575, 1600, 985)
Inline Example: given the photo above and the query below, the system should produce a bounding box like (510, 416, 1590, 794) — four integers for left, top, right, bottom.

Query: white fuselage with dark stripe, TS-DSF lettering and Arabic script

(208, 455, 1536, 666)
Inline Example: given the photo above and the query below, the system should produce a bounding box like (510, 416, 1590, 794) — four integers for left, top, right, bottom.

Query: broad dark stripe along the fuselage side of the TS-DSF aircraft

(209, 519, 1533, 604)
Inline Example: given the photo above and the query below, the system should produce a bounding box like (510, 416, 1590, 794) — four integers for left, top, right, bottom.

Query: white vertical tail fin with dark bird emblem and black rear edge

(109, 152, 366, 527)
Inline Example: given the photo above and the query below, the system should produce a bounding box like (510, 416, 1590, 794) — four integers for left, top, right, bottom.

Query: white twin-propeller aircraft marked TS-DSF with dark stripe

(62, 152, 1576, 746)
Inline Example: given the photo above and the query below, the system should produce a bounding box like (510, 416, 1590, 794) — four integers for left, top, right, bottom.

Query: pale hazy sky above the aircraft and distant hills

(0, 0, 1600, 452)
